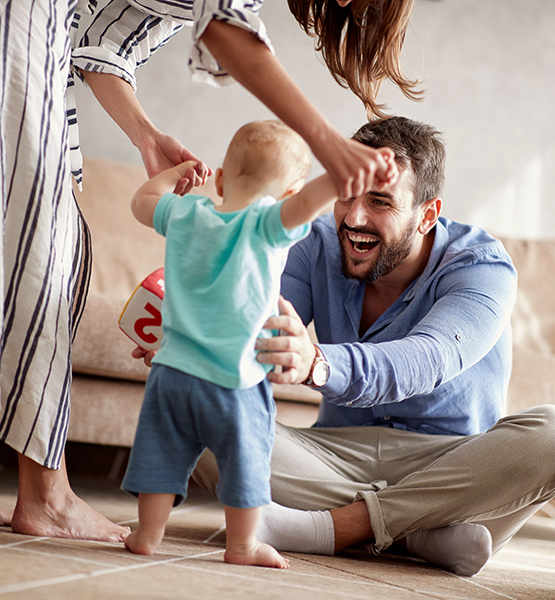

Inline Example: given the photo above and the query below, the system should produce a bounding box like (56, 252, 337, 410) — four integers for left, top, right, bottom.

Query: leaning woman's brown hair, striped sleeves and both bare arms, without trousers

(73, 0, 418, 197)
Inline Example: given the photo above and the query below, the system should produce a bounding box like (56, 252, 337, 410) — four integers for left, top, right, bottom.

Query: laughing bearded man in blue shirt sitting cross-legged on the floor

(192, 117, 555, 575)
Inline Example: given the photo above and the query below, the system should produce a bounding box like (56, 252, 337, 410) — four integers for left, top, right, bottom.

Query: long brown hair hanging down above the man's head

(288, 0, 423, 118)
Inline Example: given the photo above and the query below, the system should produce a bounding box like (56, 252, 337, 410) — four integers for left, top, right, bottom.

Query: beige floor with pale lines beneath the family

(0, 442, 555, 600)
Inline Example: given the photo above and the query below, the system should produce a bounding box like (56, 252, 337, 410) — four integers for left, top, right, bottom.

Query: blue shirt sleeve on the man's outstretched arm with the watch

(321, 260, 516, 408)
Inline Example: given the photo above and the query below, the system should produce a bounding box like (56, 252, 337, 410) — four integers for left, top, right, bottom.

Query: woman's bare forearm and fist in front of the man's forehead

(201, 20, 391, 198)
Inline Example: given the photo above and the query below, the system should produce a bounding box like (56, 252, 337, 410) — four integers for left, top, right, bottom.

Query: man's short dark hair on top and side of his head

(353, 117, 445, 206)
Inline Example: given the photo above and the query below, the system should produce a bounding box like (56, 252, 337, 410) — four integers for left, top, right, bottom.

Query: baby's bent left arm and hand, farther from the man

(131, 160, 202, 227)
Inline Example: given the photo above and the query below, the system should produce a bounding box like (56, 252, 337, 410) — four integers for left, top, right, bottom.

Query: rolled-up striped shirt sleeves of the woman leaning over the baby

(73, 0, 274, 90)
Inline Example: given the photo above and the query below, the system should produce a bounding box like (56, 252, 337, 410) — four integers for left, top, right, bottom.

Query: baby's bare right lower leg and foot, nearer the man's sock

(224, 506, 289, 569)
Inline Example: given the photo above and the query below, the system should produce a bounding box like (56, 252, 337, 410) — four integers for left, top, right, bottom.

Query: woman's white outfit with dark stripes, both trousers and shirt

(0, 0, 273, 468)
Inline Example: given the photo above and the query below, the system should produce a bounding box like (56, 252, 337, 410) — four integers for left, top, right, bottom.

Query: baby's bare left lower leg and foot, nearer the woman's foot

(125, 494, 175, 555)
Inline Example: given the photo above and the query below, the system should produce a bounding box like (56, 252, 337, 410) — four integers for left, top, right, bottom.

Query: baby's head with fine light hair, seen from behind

(218, 120, 310, 199)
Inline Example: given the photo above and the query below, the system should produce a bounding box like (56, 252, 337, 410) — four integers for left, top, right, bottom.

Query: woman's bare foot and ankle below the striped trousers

(11, 454, 130, 542)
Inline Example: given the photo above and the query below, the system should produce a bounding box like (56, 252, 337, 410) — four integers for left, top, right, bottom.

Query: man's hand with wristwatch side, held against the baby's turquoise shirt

(255, 296, 316, 384)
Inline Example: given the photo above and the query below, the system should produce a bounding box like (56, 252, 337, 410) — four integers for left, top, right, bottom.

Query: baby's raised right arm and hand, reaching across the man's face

(281, 148, 399, 230)
